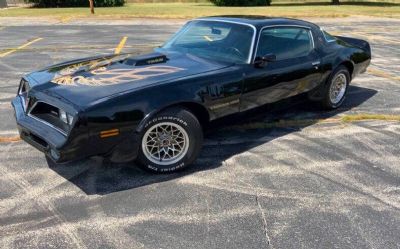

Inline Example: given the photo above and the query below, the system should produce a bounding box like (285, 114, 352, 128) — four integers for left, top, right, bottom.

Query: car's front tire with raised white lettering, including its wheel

(137, 107, 203, 173)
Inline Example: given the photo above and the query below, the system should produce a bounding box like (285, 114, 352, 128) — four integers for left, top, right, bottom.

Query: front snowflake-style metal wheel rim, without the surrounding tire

(142, 122, 189, 165)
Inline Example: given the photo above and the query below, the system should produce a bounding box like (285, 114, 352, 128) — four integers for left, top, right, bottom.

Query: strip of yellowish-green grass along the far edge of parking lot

(0, 2, 400, 19)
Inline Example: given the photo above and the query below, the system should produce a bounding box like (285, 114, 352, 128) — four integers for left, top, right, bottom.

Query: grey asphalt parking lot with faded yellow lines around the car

(0, 18, 400, 249)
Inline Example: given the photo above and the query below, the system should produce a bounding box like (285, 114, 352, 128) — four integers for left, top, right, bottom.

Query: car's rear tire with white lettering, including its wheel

(320, 66, 350, 110)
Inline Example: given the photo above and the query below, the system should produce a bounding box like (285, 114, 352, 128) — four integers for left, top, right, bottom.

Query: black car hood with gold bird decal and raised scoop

(27, 52, 231, 108)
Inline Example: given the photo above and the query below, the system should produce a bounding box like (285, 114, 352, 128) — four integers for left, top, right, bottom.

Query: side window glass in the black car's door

(257, 27, 313, 60)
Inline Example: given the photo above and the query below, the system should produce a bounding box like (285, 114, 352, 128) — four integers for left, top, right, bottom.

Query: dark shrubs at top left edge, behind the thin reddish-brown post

(25, 0, 125, 8)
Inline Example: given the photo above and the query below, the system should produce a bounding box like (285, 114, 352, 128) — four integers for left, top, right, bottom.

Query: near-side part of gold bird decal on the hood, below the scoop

(51, 65, 184, 86)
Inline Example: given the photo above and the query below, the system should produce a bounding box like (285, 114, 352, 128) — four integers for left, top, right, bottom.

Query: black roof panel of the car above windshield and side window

(195, 15, 318, 29)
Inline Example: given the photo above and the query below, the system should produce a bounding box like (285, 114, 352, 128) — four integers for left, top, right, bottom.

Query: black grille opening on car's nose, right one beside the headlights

(29, 101, 70, 134)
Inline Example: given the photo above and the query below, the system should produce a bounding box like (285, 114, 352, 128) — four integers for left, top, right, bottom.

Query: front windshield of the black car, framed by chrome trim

(162, 20, 254, 63)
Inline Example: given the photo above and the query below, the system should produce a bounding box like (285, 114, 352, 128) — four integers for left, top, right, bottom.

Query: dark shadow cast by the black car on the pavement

(49, 86, 377, 195)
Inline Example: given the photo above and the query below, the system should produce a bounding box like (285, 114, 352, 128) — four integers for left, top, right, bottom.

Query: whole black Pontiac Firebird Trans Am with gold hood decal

(12, 16, 371, 172)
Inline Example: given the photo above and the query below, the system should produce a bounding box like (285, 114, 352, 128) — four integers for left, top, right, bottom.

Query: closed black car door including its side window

(241, 26, 322, 111)
